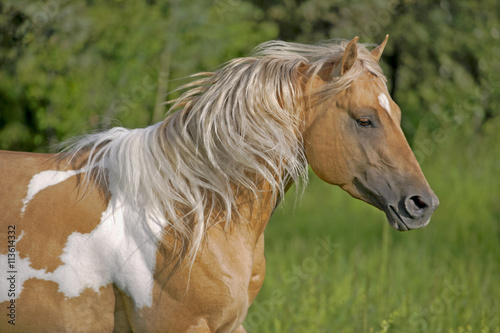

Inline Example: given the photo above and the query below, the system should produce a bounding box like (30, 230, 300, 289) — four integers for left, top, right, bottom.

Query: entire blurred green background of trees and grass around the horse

(0, 0, 500, 332)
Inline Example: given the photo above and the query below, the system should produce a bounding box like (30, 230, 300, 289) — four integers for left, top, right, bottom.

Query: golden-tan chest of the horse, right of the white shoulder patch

(121, 226, 265, 332)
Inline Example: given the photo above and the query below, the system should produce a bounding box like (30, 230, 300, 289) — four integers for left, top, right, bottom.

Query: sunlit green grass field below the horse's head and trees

(244, 124, 500, 333)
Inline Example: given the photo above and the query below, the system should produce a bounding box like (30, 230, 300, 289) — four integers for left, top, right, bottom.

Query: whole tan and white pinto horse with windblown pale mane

(0, 38, 438, 332)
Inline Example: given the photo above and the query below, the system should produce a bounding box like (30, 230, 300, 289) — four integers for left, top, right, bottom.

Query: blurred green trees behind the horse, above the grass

(0, 0, 500, 151)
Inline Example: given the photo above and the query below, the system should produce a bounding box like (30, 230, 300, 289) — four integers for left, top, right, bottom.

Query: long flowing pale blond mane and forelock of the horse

(64, 41, 383, 258)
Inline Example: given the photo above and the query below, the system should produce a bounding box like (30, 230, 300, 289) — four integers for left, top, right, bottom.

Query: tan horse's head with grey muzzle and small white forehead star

(304, 38, 439, 231)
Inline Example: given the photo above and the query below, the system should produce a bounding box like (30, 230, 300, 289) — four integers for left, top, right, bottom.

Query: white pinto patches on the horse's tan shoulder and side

(0, 171, 161, 308)
